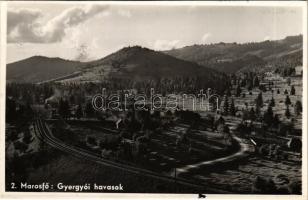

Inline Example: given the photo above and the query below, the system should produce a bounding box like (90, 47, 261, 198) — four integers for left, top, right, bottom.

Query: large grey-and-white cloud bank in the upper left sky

(7, 5, 108, 43)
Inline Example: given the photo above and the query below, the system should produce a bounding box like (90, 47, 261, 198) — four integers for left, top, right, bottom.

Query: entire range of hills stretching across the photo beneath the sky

(7, 35, 303, 83)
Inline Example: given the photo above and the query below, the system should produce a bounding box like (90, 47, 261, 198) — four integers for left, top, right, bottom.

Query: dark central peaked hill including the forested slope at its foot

(58, 46, 228, 92)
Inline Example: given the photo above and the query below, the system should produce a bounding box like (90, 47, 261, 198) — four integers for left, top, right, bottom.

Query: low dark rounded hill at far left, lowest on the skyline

(6, 56, 83, 83)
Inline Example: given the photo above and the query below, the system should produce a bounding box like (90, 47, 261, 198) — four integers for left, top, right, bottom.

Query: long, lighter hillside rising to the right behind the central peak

(164, 35, 303, 73)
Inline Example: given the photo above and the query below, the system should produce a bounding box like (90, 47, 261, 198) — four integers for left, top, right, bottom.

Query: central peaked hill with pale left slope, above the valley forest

(62, 46, 226, 82)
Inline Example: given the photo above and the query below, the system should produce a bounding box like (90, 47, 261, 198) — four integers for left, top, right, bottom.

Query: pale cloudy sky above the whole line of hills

(7, 2, 303, 63)
